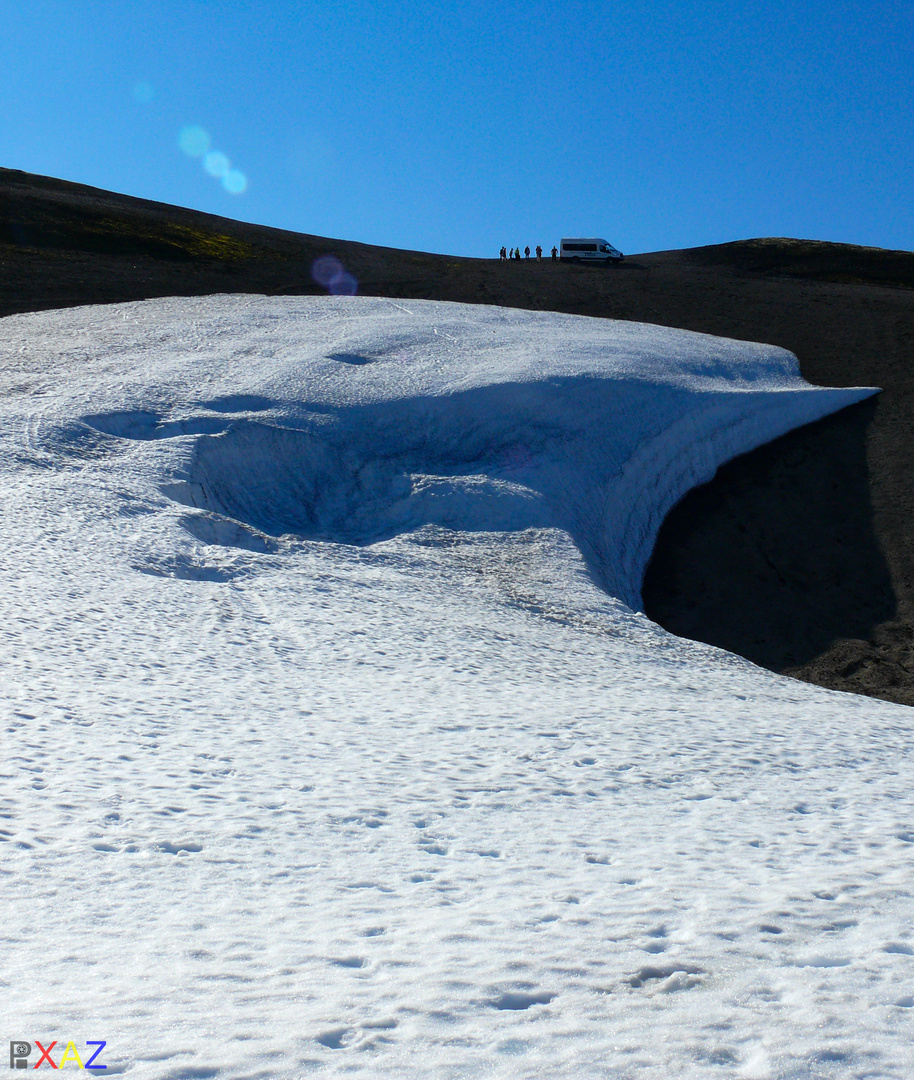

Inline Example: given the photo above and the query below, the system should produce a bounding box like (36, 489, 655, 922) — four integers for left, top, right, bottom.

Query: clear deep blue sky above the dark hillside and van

(0, 0, 914, 256)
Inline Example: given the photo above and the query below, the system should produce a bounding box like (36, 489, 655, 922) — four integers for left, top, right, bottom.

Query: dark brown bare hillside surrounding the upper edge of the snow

(0, 170, 914, 705)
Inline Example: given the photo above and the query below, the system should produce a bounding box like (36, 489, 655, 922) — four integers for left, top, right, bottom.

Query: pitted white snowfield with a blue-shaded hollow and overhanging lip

(0, 296, 914, 1078)
